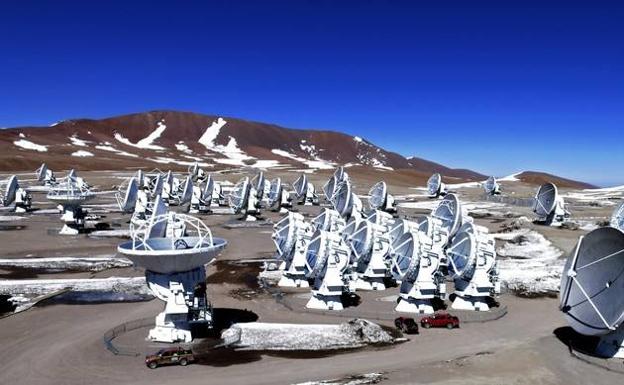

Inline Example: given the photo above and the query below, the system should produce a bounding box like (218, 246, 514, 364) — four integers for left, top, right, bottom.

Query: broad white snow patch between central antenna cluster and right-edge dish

(493, 229, 565, 297)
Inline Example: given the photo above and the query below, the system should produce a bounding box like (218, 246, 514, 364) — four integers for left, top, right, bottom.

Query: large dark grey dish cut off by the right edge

(559, 227, 624, 358)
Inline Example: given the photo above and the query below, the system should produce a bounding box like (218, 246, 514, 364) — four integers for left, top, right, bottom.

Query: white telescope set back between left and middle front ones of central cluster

(347, 210, 393, 290)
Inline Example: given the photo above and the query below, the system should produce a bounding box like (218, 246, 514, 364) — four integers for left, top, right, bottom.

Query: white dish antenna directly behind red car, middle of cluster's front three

(390, 231, 446, 314)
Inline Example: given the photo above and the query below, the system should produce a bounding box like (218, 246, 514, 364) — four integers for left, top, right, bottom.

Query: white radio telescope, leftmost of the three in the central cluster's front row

(306, 230, 350, 310)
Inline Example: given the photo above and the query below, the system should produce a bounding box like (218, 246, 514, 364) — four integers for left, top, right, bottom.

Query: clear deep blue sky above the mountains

(0, 0, 624, 185)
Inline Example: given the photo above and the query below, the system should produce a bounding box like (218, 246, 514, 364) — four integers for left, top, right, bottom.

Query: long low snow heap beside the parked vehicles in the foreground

(221, 319, 394, 350)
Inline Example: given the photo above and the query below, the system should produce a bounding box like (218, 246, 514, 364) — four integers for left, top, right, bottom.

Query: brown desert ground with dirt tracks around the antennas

(0, 170, 624, 384)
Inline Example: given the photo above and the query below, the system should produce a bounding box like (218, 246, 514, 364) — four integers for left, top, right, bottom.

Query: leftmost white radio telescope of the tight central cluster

(272, 211, 313, 287)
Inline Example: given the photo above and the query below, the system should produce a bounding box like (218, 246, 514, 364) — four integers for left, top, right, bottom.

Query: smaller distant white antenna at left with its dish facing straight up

(46, 170, 95, 235)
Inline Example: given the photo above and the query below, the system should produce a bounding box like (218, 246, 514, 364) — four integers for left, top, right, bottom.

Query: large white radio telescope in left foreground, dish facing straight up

(117, 212, 227, 343)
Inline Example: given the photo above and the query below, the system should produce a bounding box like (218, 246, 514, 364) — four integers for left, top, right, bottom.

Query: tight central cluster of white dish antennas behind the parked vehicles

(273, 169, 500, 313)
